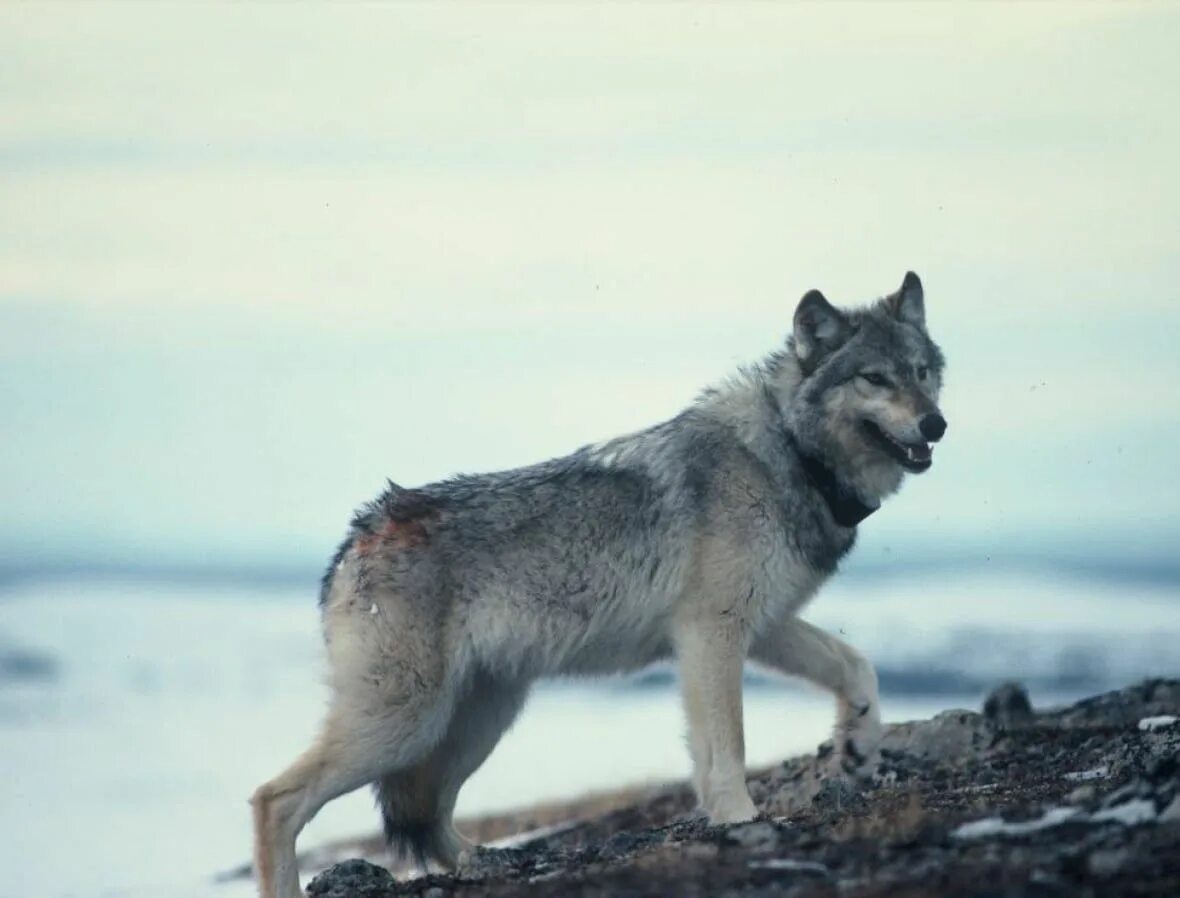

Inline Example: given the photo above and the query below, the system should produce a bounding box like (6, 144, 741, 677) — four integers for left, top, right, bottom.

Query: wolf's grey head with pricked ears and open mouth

(784, 271, 946, 499)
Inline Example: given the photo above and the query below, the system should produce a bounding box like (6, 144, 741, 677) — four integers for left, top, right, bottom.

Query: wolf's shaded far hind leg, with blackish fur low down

(374, 673, 529, 870)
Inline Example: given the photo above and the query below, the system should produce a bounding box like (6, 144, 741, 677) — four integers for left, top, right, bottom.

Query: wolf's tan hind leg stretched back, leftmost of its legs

(250, 694, 450, 898)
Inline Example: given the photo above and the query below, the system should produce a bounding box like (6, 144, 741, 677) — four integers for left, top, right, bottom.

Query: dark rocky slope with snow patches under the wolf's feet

(270, 680, 1180, 898)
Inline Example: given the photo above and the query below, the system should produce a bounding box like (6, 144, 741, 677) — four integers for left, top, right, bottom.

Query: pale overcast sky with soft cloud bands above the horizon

(0, 4, 1180, 563)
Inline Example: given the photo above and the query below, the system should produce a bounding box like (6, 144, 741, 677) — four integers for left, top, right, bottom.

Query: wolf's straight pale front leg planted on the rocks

(676, 622, 758, 824)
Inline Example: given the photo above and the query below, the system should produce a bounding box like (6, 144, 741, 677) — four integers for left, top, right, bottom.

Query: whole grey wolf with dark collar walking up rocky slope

(251, 271, 946, 898)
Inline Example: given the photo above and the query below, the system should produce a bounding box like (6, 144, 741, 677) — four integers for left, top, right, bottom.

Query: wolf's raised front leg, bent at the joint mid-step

(750, 617, 881, 776)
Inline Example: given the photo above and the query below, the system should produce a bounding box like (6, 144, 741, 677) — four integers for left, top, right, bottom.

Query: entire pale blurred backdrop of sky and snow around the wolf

(0, 4, 1180, 898)
